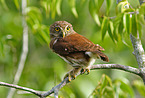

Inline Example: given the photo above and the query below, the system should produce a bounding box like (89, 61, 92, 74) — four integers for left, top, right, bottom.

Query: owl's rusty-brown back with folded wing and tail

(50, 33, 109, 61)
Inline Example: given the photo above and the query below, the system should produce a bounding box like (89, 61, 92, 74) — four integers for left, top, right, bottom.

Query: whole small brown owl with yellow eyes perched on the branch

(50, 21, 109, 81)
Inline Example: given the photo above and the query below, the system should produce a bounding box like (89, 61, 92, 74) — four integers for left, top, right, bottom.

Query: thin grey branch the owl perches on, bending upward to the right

(0, 64, 141, 98)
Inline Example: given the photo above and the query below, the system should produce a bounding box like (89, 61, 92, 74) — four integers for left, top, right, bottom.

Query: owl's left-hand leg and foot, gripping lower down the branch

(64, 68, 81, 81)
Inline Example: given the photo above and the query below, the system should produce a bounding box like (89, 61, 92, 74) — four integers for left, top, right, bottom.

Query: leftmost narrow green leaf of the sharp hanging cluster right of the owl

(101, 16, 108, 40)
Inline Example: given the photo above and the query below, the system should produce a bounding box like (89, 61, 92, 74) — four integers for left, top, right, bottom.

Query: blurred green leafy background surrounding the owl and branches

(0, 0, 145, 98)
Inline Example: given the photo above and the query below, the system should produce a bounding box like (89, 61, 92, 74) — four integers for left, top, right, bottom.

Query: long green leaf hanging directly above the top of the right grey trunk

(131, 14, 137, 37)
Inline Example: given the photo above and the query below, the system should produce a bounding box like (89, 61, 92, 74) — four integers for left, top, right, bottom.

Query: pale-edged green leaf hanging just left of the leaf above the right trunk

(123, 13, 131, 34)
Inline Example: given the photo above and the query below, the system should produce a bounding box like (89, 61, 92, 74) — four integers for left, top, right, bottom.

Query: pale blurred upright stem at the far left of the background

(7, 0, 28, 98)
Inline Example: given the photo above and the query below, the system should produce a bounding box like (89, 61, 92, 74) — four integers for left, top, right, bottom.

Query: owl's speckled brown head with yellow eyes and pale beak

(50, 21, 74, 38)
